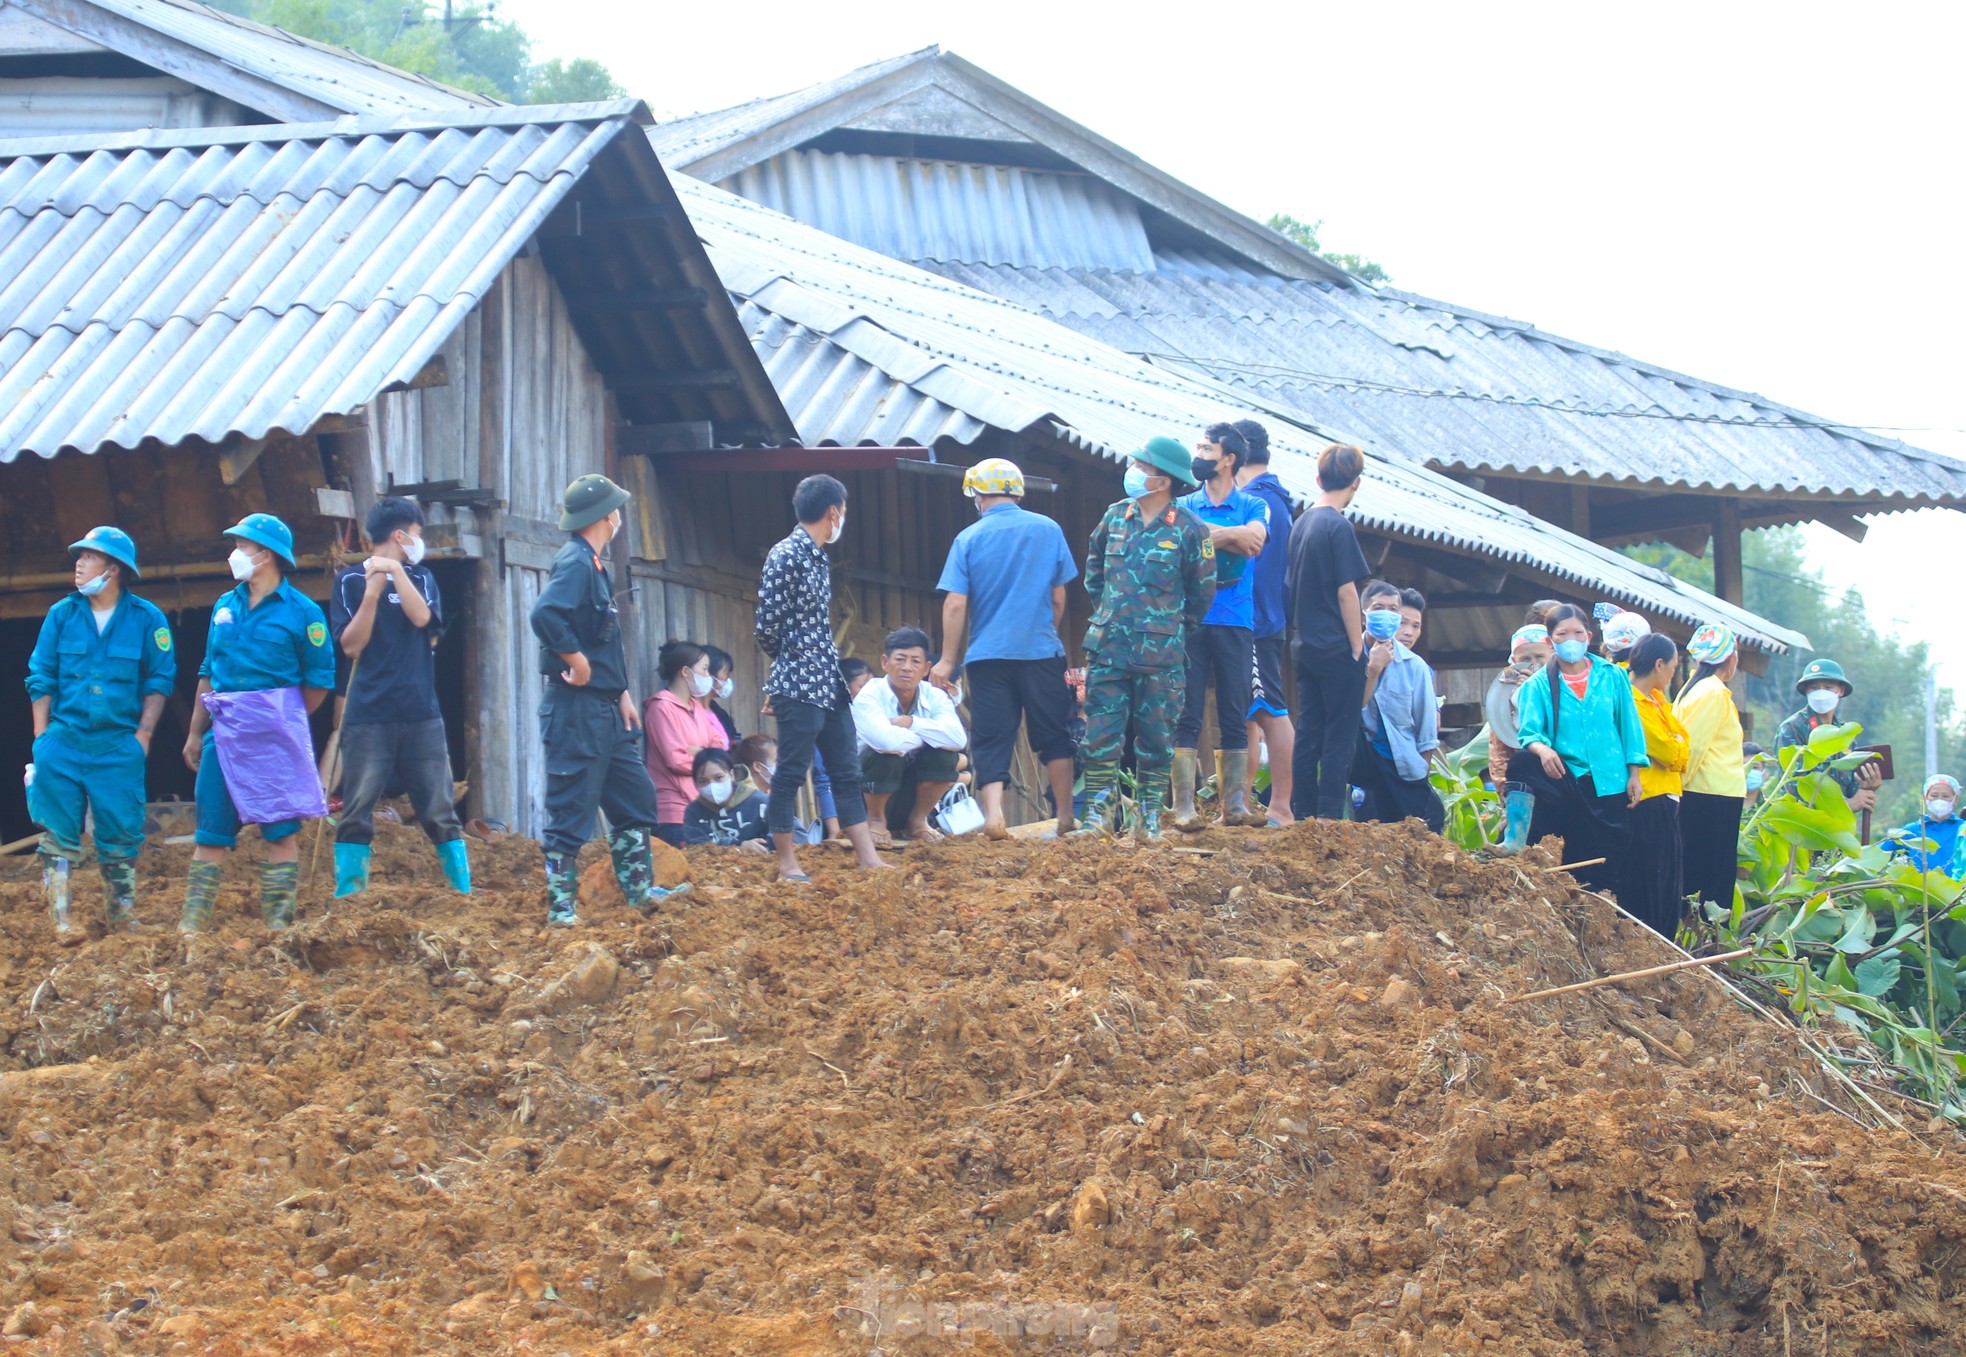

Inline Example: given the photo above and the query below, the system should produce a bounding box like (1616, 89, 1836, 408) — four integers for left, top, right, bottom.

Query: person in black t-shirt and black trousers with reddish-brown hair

(1290, 444, 1370, 820)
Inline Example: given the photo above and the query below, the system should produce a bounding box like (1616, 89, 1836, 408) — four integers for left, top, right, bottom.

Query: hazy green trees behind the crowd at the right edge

(1626, 527, 1966, 826)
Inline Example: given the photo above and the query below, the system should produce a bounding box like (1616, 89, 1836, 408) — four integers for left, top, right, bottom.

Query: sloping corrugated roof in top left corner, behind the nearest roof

(10, 0, 497, 114)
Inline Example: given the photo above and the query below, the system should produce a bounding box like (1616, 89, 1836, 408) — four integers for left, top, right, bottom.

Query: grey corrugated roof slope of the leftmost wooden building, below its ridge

(0, 100, 653, 462)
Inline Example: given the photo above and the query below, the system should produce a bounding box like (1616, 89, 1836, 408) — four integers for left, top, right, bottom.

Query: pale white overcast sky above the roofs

(501, 0, 1966, 676)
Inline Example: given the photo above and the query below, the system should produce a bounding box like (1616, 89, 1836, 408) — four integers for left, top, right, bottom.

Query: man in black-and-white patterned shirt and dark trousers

(755, 476, 887, 885)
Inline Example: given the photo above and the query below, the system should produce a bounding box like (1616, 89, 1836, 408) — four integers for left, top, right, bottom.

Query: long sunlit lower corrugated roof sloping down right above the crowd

(676, 179, 1807, 649)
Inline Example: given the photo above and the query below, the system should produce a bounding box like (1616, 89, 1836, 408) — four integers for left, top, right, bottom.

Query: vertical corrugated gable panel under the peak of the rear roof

(722, 151, 1154, 271)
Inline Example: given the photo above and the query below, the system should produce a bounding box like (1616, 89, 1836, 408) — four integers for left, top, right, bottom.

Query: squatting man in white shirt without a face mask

(853, 627, 969, 844)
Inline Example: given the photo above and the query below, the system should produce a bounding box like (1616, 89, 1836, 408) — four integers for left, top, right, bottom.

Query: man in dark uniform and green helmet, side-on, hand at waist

(533, 476, 668, 926)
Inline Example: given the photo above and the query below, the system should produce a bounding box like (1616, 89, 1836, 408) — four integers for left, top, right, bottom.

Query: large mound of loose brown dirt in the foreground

(0, 810, 1966, 1357)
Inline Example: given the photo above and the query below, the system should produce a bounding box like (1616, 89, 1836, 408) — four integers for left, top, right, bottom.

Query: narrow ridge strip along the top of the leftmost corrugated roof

(0, 98, 649, 161)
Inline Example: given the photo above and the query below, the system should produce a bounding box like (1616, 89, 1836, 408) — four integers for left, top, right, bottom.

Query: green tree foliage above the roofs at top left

(212, 0, 621, 104)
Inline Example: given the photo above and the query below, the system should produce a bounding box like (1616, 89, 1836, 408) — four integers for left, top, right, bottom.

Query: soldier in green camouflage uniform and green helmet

(1077, 437, 1215, 840)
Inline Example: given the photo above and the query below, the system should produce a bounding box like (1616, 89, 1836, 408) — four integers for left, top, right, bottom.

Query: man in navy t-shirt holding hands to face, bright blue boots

(328, 496, 472, 899)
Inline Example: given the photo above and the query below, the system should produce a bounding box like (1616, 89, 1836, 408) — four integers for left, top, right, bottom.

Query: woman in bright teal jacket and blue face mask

(1508, 604, 1649, 891)
